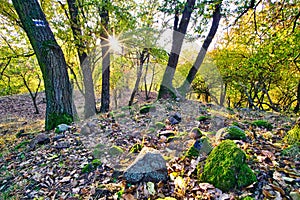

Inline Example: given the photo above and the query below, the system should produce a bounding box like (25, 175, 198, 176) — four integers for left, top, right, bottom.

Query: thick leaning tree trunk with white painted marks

(12, 0, 73, 130)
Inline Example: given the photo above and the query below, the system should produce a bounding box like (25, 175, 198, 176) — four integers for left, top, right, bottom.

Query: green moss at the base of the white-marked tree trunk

(45, 113, 73, 130)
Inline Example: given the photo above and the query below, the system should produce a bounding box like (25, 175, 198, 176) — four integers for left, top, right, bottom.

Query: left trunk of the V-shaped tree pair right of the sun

(158, 0, 195, 99)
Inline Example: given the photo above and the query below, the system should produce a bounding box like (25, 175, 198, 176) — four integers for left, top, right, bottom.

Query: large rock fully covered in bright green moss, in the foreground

(198, 140, 256, 192)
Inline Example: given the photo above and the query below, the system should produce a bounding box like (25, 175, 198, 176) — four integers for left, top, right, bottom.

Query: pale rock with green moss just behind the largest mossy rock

(216, 126, 246, 140)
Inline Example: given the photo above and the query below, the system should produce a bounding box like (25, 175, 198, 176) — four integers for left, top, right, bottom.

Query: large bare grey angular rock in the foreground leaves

(123, 147, 168, 183)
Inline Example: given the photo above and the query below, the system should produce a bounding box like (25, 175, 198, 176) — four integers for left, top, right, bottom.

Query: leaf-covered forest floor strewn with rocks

(0, 94, 300, 200)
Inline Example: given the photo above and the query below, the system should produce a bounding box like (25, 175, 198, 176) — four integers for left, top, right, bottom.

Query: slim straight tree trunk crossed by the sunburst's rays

(99, 0, 110, 113)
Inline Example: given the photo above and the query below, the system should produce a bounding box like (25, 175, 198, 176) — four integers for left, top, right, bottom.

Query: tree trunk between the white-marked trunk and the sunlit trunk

(68, 0, 96, 118)
